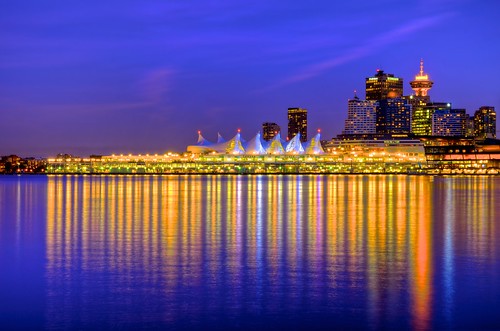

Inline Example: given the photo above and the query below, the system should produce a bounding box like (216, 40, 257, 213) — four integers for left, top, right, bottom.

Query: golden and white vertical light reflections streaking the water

(46, 175, 498, 329)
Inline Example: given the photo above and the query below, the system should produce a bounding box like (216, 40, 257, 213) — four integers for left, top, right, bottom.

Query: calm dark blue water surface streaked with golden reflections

(0, 176, 500, 330)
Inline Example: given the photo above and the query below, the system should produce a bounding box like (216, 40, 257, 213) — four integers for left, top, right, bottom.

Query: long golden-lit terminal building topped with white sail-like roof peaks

(47, 132, 426, 174)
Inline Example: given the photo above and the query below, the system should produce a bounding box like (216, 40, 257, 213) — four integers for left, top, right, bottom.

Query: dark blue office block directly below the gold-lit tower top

(376, 98, 411, 134)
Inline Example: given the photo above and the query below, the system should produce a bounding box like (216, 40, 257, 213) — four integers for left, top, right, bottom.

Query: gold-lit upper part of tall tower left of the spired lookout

(366, 70, 403, 101)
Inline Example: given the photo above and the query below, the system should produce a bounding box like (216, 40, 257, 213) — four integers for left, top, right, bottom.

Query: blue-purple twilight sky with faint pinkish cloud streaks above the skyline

(0, 0, 500, 156)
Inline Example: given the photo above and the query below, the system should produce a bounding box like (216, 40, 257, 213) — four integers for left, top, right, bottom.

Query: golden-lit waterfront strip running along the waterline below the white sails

(47, 154, 500, 175)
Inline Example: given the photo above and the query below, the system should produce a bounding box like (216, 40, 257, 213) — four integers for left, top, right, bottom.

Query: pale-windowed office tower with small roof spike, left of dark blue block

(343, 94, 377, 134)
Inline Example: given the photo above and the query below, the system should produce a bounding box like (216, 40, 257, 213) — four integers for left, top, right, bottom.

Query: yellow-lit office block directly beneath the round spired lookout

(411, 102, 451, 136)
